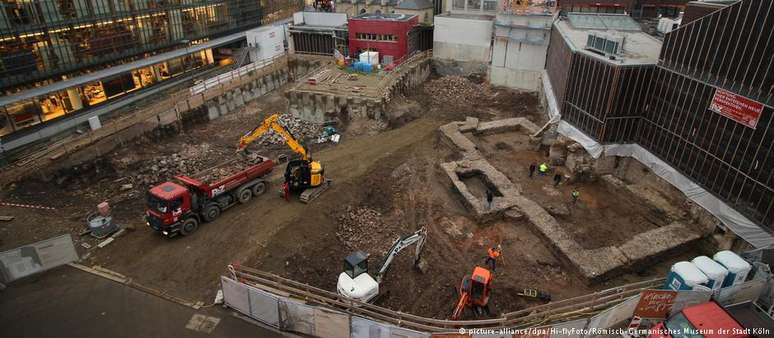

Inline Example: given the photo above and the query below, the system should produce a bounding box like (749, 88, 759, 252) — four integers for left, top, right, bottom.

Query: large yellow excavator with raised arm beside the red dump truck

(237, 114, 332, 203)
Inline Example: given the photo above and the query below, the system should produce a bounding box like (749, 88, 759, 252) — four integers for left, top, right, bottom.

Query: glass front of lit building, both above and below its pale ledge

(0, 0, 303, 136)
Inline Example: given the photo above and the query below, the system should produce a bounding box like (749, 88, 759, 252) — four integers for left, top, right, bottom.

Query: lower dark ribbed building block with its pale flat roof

(546, 13, 661, 143)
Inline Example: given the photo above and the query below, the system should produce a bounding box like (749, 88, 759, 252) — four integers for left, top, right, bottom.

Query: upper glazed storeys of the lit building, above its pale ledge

(0, 0, 261, 90)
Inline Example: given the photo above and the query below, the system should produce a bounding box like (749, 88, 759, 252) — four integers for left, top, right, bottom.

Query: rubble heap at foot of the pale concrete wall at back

(425, 75, 489, 106)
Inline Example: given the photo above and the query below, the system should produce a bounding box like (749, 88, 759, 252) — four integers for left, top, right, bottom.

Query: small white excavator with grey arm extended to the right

(336, 228, 427, 303)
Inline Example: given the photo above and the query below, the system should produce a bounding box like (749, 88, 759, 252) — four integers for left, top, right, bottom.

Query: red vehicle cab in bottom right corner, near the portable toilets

(649, 302, 750, 338)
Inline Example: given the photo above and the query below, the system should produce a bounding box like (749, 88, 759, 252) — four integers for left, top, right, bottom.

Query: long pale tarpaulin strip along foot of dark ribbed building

(543, 73, 774, 248)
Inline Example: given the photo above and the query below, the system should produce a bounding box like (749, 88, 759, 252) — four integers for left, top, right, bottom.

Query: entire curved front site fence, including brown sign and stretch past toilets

(221, 265, 770, 338)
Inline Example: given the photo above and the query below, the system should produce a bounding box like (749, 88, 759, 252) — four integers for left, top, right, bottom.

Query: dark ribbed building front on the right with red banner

(547, 0, 774, 232)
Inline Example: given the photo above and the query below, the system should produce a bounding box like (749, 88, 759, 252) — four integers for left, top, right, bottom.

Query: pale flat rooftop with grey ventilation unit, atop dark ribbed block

(555, 13, 661, 66)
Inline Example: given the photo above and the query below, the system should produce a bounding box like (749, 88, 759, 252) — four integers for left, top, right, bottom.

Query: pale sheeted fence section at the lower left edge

(0, 234, 79, 283)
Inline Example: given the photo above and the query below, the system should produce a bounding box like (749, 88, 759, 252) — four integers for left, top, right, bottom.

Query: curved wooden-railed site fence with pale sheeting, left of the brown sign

(221, 265, 663, 337)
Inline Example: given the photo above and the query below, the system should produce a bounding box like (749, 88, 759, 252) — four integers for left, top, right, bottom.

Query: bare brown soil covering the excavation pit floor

(0, 74, 704, 318)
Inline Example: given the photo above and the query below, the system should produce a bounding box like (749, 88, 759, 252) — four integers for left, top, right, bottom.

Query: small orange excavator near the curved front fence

(451, 266, 494, 320)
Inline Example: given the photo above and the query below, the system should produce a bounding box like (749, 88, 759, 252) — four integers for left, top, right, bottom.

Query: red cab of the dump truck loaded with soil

(145, 182, 191, 236)
